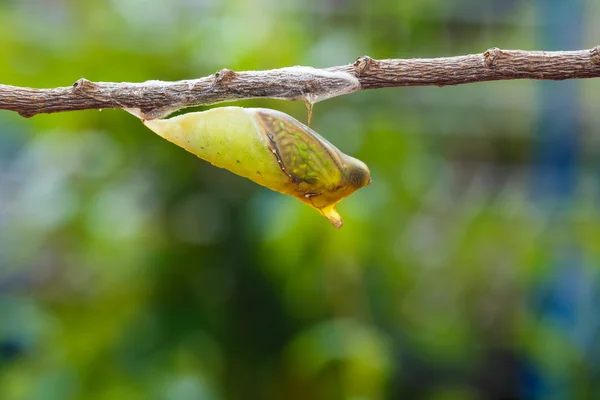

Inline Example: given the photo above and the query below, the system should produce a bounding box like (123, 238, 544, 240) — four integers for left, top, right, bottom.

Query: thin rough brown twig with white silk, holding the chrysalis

(0, 46, 600, 119)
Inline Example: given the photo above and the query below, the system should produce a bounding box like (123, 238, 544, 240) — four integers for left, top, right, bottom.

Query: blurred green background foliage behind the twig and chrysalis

(0, 0, 600, 400)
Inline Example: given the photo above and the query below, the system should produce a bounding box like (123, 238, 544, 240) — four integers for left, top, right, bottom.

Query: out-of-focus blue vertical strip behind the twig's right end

(523, 0, 600, 399)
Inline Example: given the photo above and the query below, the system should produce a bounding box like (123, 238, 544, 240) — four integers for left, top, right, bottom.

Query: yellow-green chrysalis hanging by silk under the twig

(144, 107, 371, 228)
